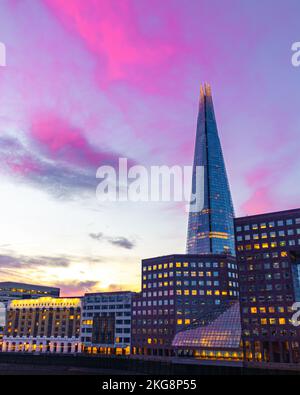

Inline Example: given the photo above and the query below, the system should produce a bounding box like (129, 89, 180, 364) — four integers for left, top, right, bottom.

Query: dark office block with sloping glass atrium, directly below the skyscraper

(132, 254, 241, 359)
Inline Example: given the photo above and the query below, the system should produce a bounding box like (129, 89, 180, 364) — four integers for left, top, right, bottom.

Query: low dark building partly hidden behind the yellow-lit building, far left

(0, 282, 60, 306)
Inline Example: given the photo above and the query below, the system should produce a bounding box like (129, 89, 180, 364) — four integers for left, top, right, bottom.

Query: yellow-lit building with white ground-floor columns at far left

(2, 297, 81, 353)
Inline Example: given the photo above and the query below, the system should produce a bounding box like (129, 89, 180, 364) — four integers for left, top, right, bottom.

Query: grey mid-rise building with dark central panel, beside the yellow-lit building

(81, 292, 135, 355)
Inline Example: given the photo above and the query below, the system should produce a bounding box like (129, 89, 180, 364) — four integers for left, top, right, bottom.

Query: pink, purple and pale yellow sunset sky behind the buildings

(0, 0, 300, 295)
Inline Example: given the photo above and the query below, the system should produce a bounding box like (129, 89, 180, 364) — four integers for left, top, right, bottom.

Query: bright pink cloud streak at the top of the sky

(46, 0, 179, 87)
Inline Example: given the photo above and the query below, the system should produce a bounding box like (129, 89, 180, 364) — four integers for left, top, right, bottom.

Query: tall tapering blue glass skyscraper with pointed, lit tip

(187, 84, 235, 255)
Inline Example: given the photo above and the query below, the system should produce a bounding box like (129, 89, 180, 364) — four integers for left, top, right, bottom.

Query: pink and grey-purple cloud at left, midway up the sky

(0, 114, 133, 200)
